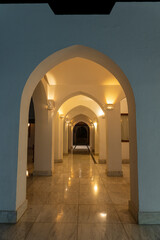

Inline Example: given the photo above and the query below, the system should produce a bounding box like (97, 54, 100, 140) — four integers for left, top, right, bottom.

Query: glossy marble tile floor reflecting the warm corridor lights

(0, 149, 160, 240)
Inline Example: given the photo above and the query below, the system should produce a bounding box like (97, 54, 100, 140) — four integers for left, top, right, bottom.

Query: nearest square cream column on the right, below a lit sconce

(106, 103, 123, 176)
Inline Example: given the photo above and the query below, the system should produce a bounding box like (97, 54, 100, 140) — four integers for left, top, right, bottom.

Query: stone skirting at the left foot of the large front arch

(0, 200, 28, 223)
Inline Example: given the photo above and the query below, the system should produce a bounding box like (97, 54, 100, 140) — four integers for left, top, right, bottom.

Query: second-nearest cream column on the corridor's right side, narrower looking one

(98, 116, 107, 163)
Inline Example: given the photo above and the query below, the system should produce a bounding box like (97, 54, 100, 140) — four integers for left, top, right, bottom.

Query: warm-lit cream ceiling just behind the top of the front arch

(45, 57, 120, 86)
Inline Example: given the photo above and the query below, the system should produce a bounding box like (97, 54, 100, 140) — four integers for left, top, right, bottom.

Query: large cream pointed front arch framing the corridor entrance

(16, 45, 139, 221)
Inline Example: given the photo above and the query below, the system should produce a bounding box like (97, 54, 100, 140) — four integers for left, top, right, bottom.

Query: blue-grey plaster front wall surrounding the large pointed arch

(0, 2, 160, 216)
